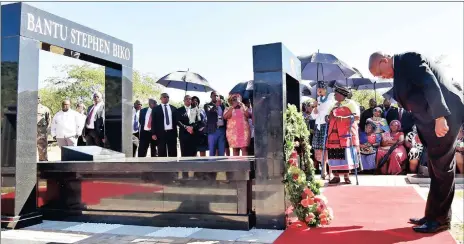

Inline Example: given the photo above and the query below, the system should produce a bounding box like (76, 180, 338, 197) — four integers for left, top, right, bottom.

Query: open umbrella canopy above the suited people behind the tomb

(156, 71, 214, 92)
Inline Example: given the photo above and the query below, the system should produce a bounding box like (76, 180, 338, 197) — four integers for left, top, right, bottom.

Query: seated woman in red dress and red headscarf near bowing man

(376, 120, 407, 175)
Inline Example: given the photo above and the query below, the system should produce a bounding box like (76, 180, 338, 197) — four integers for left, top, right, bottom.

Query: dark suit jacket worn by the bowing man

(393, 52, 464, 125)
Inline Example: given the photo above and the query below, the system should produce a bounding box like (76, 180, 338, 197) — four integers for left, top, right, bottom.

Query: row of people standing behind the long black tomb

(37, 92, 254, 161)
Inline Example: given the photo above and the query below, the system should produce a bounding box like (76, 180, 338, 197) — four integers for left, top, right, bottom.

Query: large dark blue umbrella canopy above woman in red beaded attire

(298, 52, 356, 81)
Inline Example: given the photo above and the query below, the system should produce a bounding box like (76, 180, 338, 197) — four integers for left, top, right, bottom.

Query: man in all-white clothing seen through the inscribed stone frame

(51, 100, 82, 147)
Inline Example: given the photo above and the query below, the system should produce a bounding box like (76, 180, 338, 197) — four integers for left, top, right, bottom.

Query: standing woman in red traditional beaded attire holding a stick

(326, 86, 360, 184)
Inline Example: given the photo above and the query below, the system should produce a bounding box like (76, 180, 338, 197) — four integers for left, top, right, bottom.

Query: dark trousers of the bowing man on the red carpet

(416, 111, 464, 224)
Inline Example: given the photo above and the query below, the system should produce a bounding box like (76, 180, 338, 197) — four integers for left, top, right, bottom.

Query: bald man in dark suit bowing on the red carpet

(369, 52, 464, 233)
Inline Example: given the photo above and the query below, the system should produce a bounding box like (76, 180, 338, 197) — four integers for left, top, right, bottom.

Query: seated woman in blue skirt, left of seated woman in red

(359, 119, 381, 171)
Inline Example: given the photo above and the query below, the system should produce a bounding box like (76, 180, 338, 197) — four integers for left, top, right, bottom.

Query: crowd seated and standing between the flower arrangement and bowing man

(302, 81, 464, 184)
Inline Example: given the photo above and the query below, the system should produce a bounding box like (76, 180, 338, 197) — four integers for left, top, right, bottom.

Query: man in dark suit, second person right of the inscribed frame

(139, 99, 158, 157)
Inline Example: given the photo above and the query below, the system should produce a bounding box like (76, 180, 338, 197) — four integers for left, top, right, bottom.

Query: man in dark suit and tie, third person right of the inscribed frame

(151, 93, 177, 157)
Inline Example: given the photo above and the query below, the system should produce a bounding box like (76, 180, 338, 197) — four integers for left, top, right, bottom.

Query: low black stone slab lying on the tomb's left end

(61, 146, 126, 161)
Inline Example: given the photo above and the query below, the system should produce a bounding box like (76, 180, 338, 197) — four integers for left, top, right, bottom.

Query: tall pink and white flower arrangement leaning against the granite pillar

(283, 104, 333, 226)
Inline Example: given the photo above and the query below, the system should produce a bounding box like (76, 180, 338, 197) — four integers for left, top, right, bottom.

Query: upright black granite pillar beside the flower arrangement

(253, 43, 301, 229)
